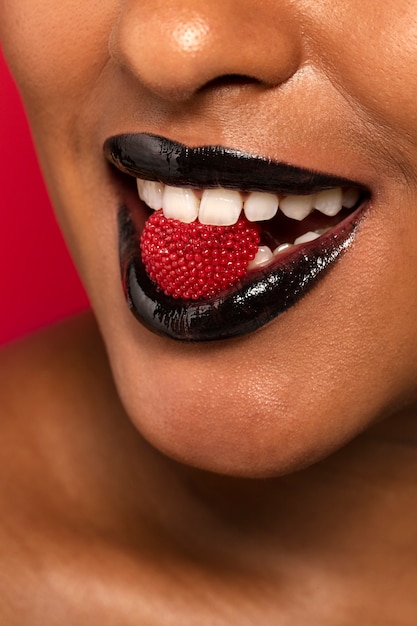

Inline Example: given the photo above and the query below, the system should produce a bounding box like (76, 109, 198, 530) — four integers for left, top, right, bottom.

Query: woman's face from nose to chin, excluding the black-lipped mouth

(0, 0, 417, 476)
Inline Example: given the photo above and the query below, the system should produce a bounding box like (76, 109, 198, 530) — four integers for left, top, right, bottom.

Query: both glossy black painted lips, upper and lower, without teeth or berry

(104, 134, 363, 341)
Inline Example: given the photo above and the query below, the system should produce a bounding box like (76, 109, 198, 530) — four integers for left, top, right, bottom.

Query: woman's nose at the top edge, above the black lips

(110, 0, 302, 101)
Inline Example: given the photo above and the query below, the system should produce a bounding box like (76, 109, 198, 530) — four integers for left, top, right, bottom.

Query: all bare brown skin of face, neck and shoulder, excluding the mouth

(0, 0, 417, 626)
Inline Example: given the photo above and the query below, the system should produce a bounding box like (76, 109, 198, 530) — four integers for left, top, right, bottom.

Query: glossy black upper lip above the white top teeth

(103, 133, 365, 195)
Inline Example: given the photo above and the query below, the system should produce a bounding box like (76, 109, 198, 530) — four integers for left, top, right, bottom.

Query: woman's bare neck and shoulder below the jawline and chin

(0, 316, 417, 626)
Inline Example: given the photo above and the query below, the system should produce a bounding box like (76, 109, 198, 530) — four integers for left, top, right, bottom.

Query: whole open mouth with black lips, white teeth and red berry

(104, 133, 370, 341)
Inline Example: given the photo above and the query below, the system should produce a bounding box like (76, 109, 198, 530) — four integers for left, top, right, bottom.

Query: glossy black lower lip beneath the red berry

(118, 199, 365, 342)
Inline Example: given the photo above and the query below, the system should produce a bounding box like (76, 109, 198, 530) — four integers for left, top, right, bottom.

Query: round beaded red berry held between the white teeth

(140, 211, 260, 300)
